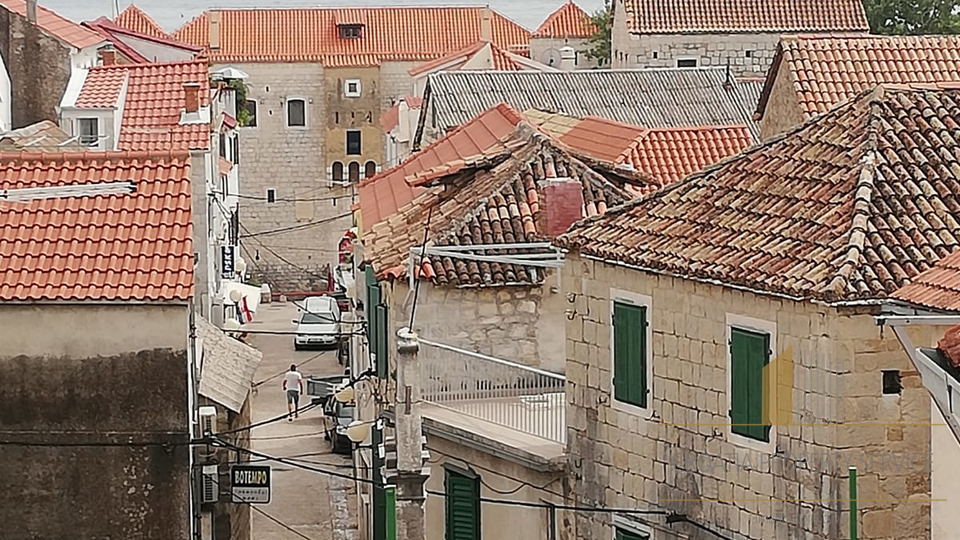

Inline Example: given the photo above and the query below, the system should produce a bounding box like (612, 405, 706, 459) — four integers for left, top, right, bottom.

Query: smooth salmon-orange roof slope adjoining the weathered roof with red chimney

(359, 104, 520, 230)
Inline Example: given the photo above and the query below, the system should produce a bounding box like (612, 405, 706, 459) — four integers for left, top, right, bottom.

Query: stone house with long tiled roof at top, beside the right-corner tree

(611, 0, 870, 77)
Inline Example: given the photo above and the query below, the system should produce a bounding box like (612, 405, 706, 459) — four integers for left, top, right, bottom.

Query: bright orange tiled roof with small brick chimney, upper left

(77, 60, 210, 150)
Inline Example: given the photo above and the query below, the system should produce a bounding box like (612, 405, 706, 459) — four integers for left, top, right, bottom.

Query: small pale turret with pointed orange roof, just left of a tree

(530, 0, 600, 70)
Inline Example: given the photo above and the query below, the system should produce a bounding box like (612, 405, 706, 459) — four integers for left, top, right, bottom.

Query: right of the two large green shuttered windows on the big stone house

(730, 328, 770, 442)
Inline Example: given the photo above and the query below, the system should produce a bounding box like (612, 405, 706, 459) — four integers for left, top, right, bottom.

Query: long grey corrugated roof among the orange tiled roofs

(417, 67, 760, 141)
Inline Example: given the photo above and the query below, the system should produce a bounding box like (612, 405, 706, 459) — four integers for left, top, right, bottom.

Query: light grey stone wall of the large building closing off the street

(228, 64, 352, 292)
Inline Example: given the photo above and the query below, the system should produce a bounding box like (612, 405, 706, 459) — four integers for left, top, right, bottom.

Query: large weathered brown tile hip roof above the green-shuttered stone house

(561, 86, 960, 301)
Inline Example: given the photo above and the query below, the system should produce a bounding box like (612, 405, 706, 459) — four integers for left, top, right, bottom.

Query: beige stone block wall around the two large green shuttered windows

(563, 255, 938, 540)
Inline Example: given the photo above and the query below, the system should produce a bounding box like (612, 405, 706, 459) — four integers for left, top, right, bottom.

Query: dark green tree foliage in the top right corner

(863, 0, 960, 36)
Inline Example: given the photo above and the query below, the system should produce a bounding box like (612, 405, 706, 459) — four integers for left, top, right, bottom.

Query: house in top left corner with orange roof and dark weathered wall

(0, 0, 107, 131)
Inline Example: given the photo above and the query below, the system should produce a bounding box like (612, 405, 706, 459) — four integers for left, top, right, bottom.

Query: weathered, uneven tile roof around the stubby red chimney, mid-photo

(362, 122, 628, 286)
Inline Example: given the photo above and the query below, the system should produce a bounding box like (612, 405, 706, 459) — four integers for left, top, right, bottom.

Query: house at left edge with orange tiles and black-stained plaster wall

(0, 152, 196, 540)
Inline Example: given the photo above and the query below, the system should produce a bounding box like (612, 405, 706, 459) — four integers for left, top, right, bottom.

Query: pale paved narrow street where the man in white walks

(247, 303, 357, 540)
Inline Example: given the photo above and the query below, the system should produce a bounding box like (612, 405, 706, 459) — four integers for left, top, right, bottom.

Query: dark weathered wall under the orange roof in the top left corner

(0, 8, 70, 129)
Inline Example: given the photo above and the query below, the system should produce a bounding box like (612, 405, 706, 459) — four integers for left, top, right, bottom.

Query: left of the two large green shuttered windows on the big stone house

(613, 302, 649, 408)
